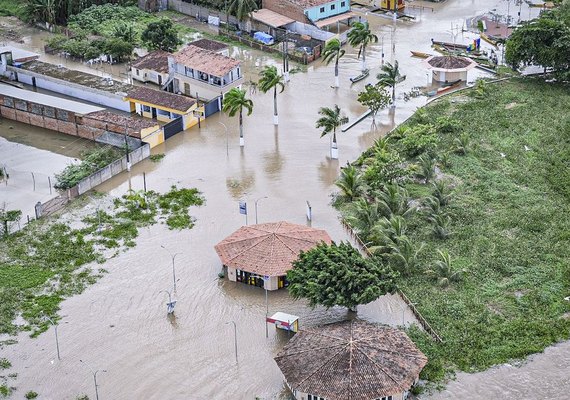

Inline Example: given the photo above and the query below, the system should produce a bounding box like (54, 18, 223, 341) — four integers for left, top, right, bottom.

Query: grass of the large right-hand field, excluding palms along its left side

(341, 79, 570, 381)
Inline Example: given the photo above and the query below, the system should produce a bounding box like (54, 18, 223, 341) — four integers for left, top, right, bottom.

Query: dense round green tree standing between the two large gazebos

(287, 242, 397, 311)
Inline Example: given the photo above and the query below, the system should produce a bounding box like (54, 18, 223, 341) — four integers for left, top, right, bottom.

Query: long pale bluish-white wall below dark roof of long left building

(7, 66, 130, 112)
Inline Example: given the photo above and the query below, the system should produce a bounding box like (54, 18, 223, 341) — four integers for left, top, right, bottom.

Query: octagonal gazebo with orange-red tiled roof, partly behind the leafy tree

(215, 221, 332, 290)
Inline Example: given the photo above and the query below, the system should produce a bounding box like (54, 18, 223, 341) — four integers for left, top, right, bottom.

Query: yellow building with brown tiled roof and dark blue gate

(125, 86, 204, 147)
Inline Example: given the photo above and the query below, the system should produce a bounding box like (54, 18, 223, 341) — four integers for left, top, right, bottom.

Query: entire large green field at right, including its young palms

(334, 79, 570, 381)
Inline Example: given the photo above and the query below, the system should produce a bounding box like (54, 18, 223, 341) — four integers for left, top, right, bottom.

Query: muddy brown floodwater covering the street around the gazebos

(1, 0, 570, 400)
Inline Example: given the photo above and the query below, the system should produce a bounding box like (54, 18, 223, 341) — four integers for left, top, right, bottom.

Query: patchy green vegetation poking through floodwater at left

(0, 187, 204, 336)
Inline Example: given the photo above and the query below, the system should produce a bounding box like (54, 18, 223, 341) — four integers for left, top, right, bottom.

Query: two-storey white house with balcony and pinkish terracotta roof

(168, 44, 243, 106)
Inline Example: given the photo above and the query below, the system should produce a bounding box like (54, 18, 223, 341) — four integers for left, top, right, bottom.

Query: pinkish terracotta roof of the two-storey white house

(173, 44, 240, 77)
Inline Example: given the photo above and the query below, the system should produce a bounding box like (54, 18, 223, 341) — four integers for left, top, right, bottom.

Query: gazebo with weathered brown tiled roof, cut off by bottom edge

(275, 320, 427, 400)
